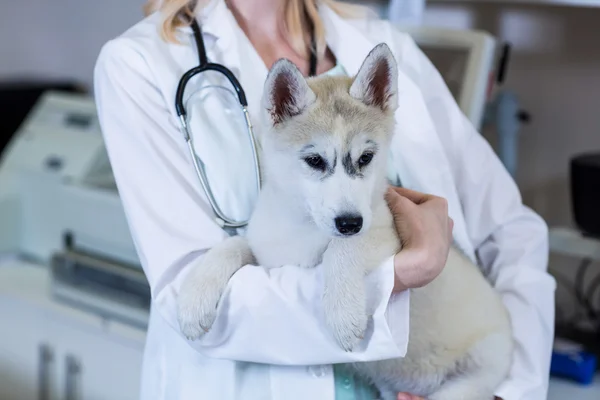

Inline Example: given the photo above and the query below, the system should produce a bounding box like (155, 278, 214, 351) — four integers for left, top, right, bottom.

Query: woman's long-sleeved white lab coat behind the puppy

(95, 0, 555, 400)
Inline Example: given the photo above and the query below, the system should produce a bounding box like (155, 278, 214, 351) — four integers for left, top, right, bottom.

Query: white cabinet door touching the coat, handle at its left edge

(51, 325, 143, 400)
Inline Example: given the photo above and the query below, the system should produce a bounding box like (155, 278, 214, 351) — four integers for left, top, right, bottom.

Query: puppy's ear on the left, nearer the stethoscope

(263, 59, 316, 125)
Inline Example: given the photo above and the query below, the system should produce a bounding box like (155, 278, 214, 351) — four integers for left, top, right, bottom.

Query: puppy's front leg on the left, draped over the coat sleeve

(177, 236, 254, 340)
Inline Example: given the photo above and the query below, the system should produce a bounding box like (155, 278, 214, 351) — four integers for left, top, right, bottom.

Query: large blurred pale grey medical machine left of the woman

(0, 92, 150, 326)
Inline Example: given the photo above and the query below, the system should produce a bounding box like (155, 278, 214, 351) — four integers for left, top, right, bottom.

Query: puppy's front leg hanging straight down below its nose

(323, 238, 368, 351)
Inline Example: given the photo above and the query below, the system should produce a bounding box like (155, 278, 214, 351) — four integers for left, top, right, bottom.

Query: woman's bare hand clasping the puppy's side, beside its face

(386, 187, 454, 292)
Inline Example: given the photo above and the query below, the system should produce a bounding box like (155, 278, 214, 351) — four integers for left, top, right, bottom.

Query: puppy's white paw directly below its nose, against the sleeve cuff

(324, 295, 368, 351)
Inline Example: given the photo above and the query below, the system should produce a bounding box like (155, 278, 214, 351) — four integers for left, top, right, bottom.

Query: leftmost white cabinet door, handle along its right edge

(0, 296, 58, 400)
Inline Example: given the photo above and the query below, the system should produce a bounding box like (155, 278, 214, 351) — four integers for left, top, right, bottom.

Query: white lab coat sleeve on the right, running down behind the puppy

(401, 35, 555, 400)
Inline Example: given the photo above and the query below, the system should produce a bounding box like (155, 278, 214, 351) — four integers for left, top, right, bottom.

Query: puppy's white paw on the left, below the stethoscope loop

(177, 266, 224, 340)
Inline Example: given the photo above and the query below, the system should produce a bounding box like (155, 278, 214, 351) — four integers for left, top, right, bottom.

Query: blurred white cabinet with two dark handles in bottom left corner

(0, 276, 143, 400)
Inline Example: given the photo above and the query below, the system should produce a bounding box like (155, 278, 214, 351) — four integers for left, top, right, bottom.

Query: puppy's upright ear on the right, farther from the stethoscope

(350, 43, 398, 112)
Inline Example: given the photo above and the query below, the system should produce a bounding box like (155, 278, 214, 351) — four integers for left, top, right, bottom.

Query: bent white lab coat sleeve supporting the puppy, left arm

(95, 37, 409, 365)
